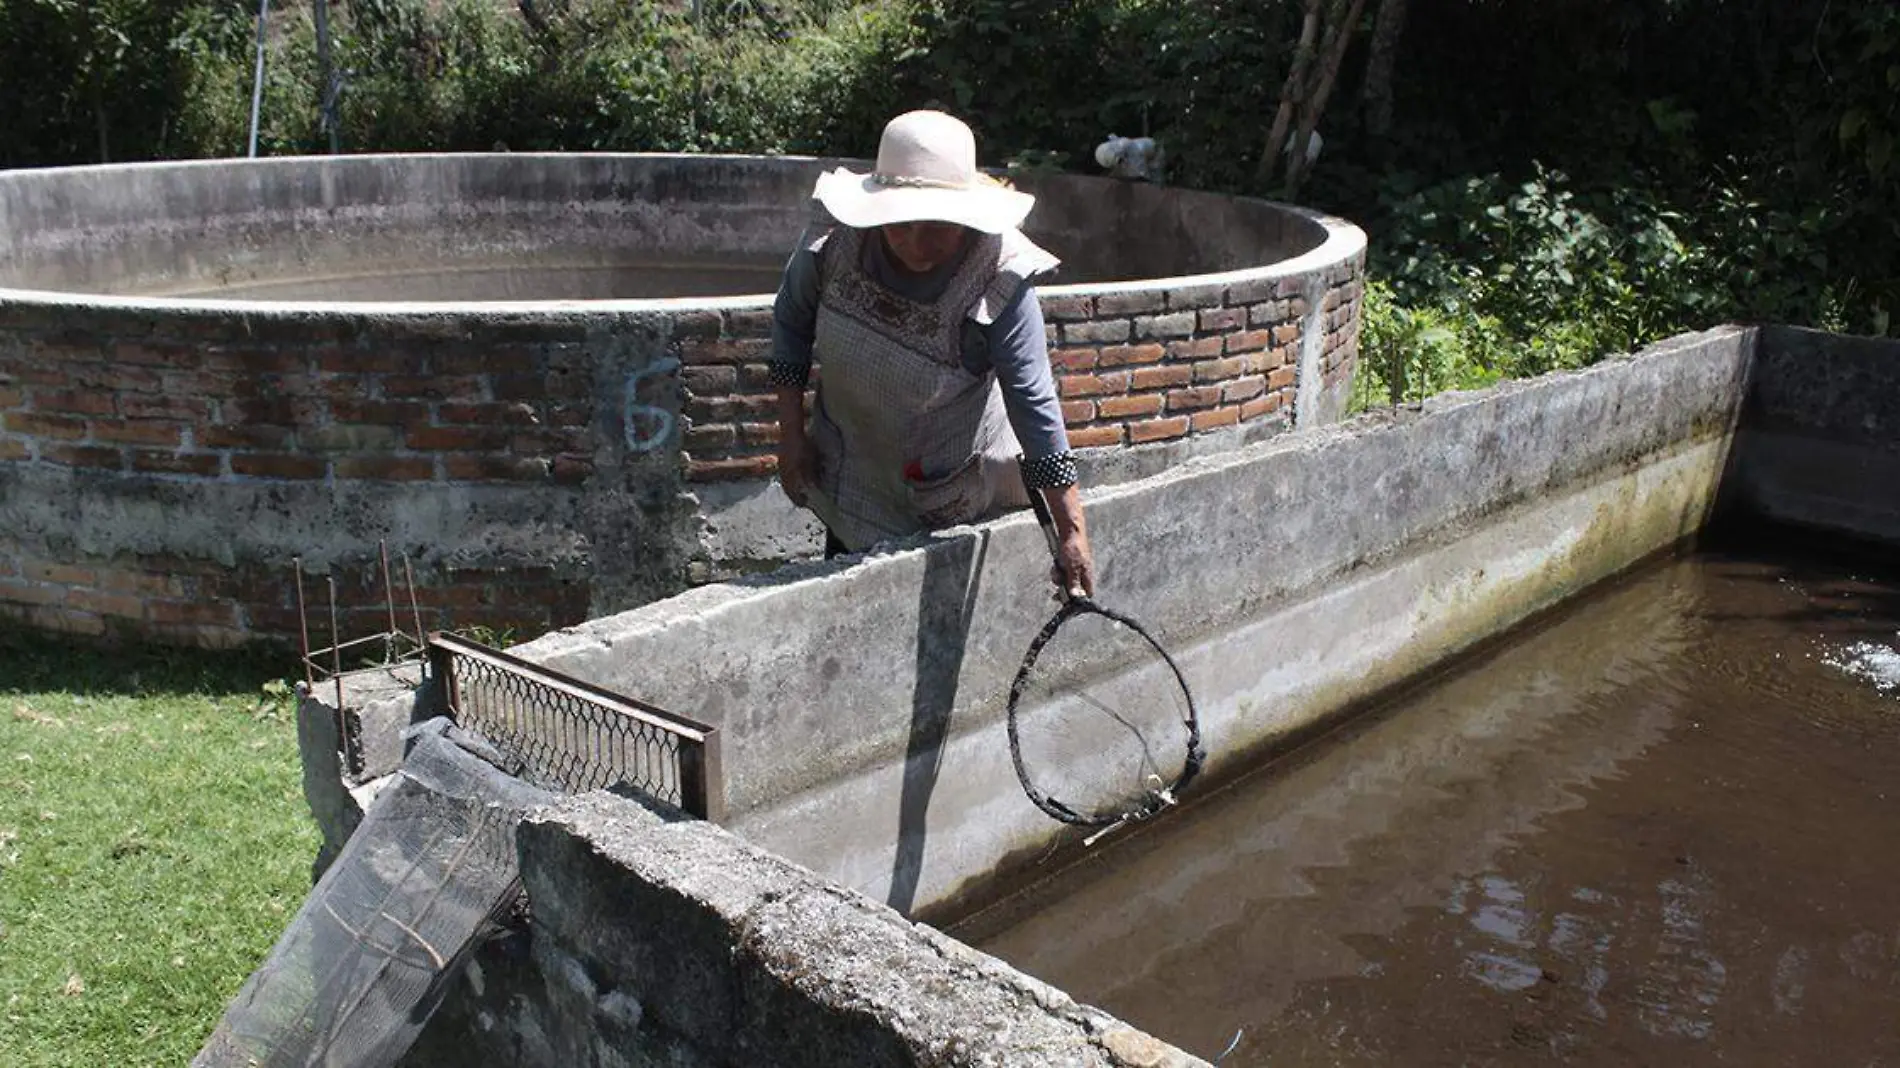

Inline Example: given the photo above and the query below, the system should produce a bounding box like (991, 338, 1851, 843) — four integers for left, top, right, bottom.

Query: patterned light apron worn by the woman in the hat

(809, 226, 1056, 551)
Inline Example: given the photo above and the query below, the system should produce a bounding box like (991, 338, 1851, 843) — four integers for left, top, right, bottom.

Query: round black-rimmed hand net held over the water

(1009, 602, 1199, 825)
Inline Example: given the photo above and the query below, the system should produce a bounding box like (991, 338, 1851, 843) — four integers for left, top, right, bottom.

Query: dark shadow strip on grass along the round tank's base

(0, 620, 300, 697)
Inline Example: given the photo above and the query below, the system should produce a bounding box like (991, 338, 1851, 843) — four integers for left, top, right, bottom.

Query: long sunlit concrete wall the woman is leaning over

(501, 319, 1754, 914)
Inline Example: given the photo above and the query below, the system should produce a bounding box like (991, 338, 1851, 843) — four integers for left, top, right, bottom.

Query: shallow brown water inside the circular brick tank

(146, 262, 779, 302)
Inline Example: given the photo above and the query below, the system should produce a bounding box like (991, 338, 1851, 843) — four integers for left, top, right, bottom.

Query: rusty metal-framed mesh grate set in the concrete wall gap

(429, 633, 726, 821)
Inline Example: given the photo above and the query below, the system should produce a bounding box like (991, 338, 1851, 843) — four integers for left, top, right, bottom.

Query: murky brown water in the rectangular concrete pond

(954, 555, 1900, 1068)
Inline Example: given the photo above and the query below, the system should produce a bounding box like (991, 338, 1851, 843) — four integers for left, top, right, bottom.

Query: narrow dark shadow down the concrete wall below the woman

(885, 532, 990, 904)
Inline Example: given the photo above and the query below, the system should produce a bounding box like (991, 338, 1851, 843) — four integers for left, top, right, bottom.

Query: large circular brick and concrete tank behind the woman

(0, 154, 1364, 644)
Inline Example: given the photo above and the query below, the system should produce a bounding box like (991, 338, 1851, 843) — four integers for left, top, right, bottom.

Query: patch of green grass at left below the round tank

(0, 629, 317, 1068)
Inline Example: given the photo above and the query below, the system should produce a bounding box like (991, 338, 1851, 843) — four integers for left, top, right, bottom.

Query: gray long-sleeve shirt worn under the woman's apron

(771, 239, 1075, 486)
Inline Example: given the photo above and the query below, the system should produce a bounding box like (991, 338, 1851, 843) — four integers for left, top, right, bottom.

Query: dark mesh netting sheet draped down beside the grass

(192, 720, 555, 1068)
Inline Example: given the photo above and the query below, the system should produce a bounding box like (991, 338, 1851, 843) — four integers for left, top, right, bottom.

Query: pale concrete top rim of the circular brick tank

(0, 152, 1366, 319)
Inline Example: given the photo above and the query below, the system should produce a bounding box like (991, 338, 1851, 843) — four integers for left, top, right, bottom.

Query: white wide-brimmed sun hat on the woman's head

(811, 112, 1036, 234)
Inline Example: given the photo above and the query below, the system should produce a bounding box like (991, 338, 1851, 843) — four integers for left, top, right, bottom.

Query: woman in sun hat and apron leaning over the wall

(771, 112, 1094, 595)
